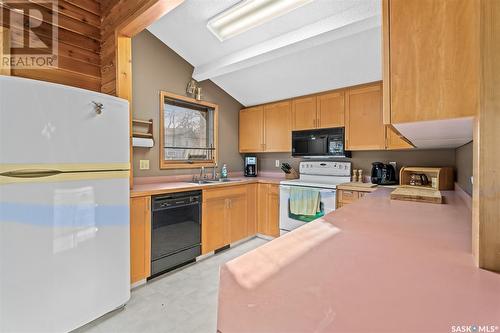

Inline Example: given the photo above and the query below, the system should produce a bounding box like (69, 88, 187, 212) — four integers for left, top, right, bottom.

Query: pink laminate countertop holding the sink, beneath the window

(130, 175, 285, 198)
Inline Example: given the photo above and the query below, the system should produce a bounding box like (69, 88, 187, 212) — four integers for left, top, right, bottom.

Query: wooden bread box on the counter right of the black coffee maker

(399, 167, 455, 191)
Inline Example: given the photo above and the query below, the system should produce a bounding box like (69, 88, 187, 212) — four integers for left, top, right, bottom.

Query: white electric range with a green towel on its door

(280, 161, 351, 234)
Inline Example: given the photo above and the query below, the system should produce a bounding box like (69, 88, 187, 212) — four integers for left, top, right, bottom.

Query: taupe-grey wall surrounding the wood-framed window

(132, 30, 243, 177)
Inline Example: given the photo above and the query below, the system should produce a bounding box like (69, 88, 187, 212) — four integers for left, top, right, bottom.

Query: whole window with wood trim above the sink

(160, 91, 218, 169)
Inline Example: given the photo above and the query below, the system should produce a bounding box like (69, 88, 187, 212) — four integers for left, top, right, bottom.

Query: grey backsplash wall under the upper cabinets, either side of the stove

(257, 149, 456, 179)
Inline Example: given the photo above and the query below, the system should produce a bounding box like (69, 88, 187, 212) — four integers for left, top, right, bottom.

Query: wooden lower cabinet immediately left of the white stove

(257, 184, 280, 237)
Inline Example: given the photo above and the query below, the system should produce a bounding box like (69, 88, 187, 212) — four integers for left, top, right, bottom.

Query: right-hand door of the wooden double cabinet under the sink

(228, 190, 249, 243)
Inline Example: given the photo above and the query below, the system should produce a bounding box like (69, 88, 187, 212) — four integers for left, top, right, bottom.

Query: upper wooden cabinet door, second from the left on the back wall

(264, 101, 292, 152)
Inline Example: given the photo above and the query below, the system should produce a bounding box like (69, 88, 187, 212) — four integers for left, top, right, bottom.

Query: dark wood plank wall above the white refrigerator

(0, 0, 101, 91)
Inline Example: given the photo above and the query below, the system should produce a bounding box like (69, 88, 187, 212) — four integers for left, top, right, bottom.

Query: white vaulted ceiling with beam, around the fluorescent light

(148, 0, 382, 106)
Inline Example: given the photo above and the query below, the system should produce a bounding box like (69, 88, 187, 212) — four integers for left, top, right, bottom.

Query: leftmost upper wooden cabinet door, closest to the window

(239, 106, 264, 152)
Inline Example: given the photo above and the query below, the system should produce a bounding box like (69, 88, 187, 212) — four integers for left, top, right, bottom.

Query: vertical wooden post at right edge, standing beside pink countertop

(472, 0, 500, 272)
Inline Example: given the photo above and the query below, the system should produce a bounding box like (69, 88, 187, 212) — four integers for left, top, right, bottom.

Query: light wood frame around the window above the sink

(160, 91, 219, 170)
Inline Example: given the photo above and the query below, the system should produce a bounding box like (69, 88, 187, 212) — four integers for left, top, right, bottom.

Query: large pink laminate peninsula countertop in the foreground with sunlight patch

(218, 188, 500, 333)
